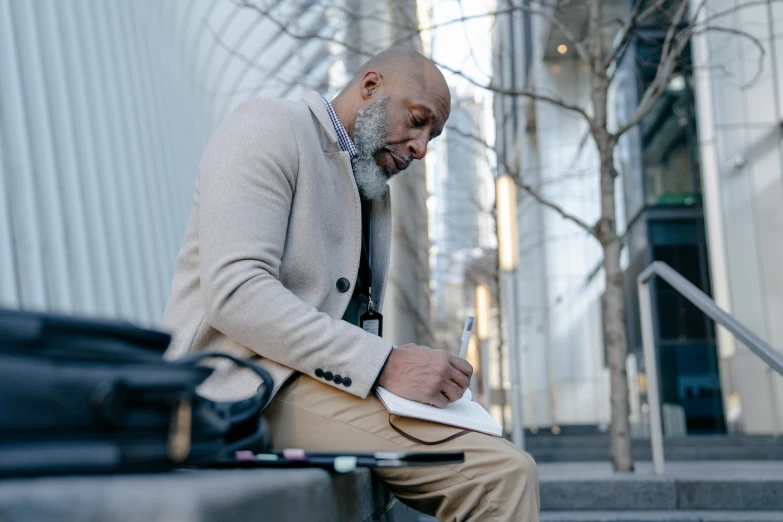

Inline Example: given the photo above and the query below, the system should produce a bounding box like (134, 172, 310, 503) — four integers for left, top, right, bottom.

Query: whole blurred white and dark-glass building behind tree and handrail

(494, 1, 783, 435)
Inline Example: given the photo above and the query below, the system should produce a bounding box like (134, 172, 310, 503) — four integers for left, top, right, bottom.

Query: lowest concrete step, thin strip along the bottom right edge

(541, 511, 783, 522)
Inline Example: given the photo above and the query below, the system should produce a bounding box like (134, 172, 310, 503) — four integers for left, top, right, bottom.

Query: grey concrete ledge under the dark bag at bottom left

(0, 469, 418, 522)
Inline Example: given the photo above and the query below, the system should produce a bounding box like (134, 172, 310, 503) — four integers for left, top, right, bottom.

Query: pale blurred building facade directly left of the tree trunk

(495, 0, 609, 431)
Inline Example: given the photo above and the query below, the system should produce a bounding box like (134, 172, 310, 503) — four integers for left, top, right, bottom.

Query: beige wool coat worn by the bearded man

(163, 92, 392, 399)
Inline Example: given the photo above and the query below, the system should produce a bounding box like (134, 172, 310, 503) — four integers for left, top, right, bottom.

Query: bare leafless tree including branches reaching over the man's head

(217, 0, 781, 472)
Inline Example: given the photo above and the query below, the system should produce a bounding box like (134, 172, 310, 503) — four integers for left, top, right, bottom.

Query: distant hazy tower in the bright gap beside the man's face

(427, 89, 501, 408)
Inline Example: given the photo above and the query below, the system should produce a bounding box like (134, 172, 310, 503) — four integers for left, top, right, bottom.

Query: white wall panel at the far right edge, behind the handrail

(697, 0, 783, 433)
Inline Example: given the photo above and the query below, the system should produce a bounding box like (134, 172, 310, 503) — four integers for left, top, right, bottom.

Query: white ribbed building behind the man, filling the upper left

(0, 0, 431, 350)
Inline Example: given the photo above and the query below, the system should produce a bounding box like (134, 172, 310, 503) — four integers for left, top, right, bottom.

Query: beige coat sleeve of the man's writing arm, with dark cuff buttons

(198, 98, 392, 398)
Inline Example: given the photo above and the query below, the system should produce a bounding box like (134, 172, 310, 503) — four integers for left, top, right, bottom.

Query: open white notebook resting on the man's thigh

(375, 386, 503, 437)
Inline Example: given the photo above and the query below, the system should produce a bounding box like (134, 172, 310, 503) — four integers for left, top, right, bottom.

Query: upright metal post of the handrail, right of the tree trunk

(637, 279, 664, 475)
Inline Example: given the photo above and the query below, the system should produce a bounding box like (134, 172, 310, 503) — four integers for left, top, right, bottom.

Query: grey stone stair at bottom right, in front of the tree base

(539, 461, 783, 522)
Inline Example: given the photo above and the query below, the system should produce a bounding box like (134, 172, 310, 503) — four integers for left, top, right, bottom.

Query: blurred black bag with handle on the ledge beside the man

(0, 310, 274, 475)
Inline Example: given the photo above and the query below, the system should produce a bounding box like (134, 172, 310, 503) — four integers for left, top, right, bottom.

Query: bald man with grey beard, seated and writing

(164, 48, 539, 521)
